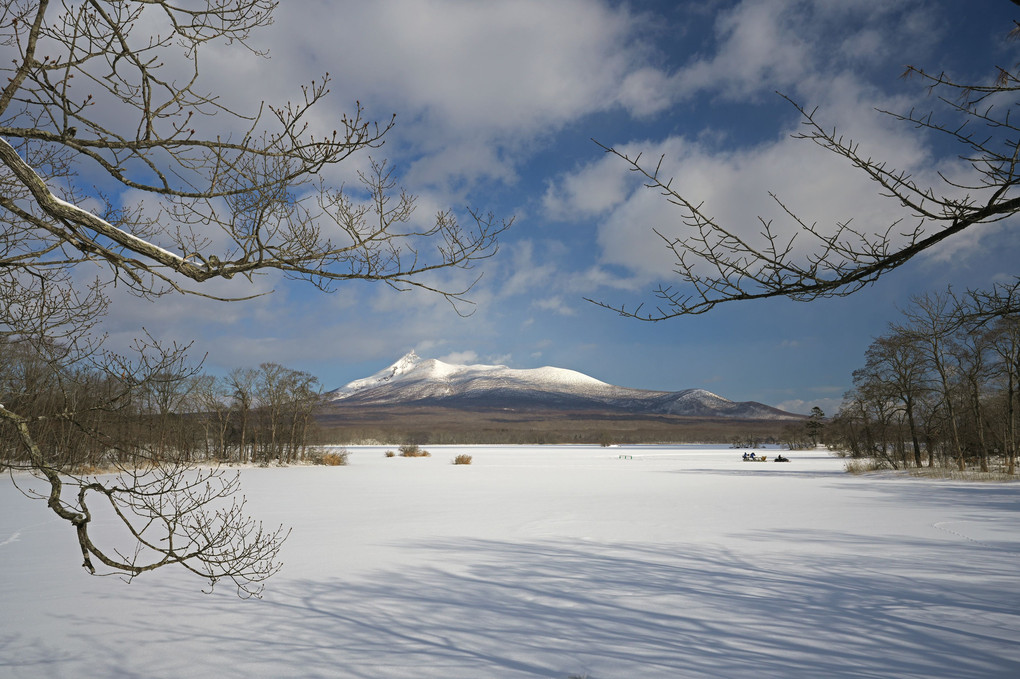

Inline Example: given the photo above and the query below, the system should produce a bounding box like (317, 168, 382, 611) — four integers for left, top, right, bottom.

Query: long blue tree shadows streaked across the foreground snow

(19, 530, 1020, 679)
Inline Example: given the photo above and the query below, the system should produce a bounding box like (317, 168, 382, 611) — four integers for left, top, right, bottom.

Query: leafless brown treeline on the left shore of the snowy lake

(0, 342, 319, 471)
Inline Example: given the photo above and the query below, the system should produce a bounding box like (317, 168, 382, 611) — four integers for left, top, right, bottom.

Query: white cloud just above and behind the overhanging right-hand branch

(591, 122, 934, 278)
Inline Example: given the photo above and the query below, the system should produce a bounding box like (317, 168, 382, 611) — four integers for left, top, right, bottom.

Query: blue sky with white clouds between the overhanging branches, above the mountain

(101, 0, 1020, 413)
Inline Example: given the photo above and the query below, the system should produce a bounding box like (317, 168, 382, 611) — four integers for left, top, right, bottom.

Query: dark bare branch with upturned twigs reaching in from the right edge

(591, 15, 1020, 320)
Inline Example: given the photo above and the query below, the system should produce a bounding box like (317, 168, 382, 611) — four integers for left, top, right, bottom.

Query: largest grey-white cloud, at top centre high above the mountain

(241, 0, 668, 187)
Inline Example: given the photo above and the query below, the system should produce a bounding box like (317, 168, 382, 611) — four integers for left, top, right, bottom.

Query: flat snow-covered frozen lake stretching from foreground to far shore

(0, 447, 1020, 679)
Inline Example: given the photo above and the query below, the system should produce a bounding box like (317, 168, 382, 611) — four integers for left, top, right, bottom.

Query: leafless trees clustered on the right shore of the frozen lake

(829, 283, 1020, 474)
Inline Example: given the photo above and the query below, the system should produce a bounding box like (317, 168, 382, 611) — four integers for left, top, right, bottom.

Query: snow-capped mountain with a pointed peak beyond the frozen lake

(324, 352, 803, 420)
